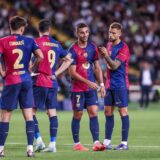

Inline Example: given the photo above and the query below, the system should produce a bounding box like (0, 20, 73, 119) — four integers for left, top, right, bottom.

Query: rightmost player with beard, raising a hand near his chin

(99, 22, 130, 150)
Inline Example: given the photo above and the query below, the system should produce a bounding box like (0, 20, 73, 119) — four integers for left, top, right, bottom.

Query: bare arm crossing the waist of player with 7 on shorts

(69, 65, 98, 89)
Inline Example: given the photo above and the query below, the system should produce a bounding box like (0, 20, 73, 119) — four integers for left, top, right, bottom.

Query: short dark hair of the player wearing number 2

(9, 16, 27, 30)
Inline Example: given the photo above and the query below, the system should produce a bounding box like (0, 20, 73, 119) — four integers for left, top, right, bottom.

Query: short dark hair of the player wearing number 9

(38, 19, 51, 33)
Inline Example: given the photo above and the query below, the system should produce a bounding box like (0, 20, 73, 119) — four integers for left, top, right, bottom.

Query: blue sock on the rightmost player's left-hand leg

(105, 115, 114, 140)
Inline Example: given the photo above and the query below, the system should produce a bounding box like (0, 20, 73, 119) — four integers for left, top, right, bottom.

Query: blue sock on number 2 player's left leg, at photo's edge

(0, 122, 9, 146)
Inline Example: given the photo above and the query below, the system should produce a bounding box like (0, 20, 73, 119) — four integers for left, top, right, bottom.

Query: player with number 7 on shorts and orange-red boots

(69, 23, 105, 151)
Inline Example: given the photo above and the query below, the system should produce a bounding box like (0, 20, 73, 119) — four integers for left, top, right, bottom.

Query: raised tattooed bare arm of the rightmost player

(99, 47, 121, 70)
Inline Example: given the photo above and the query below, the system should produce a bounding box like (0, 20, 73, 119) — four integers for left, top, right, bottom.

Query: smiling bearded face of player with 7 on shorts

(77, 27, 89, 42)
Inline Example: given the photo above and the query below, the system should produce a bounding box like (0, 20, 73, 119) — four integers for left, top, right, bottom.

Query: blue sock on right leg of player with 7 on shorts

(90, 116, 99, 141)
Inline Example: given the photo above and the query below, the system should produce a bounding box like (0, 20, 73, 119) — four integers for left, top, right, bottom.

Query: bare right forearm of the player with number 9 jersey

(55, 55, 73, 76)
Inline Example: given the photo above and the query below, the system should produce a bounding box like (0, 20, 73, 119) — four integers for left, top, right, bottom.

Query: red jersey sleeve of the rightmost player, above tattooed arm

(116, 45, 130, 62)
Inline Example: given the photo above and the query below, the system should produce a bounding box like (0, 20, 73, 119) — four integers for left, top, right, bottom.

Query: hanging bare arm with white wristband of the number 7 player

(94, 60, 106, 98)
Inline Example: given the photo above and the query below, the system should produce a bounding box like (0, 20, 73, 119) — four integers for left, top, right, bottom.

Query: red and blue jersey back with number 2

(0, 34, 38, 85)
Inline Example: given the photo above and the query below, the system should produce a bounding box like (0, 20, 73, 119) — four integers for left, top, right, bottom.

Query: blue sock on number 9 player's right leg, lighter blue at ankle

(49, 116, 58, 142)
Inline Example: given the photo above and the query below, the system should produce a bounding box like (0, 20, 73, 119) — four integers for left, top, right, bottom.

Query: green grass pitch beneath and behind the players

(3, 103, 160, 160)
